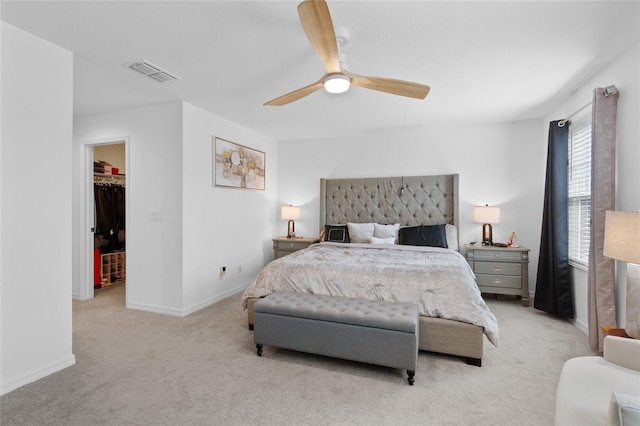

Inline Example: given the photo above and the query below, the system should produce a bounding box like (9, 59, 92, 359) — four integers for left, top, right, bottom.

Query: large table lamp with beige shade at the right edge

(603, 211, 640, 339)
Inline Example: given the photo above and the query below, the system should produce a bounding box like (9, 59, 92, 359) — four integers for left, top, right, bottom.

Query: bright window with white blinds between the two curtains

(569, 121, 591, 267)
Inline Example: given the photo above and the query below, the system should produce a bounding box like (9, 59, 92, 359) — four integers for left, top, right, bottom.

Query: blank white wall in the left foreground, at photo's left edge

(0, 22, 75, 394)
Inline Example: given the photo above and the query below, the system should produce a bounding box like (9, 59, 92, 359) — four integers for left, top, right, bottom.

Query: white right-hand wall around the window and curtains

(543, 43, 640, 332)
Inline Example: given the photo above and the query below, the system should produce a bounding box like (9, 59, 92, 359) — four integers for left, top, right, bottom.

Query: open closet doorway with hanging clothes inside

(83, 138, 128, 305)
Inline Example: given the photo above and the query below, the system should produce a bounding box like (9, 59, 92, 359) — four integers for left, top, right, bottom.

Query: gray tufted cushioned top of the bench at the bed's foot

(254, 291, 418, 333)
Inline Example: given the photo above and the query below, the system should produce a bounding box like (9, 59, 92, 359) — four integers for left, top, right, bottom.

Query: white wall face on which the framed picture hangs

(182, 103, 278, 313)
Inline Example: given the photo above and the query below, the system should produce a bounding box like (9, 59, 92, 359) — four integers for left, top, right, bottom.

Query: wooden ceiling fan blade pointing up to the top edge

(298, 0, 340, 74)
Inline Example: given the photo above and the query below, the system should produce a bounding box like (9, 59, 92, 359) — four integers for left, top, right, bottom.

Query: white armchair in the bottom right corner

(555, 336, 640, 426)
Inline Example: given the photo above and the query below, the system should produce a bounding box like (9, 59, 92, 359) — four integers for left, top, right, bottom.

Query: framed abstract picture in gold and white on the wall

(211, 136, 266, 191)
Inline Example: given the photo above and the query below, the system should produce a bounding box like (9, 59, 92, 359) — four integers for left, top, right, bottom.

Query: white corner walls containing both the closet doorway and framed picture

(74, 102, 278, 316)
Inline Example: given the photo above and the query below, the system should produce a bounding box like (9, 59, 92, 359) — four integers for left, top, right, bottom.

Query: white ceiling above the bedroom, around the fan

(0, 0, 640, 140)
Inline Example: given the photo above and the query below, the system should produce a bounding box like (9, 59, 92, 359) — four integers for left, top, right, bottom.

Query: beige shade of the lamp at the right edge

(603, 211, 640, 264)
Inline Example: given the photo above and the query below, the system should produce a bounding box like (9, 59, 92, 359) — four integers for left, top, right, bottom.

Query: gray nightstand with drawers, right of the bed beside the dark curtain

(465, 244, 530, 306)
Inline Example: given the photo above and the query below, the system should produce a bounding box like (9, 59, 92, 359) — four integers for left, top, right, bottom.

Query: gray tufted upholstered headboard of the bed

(320, 174, 459, 230)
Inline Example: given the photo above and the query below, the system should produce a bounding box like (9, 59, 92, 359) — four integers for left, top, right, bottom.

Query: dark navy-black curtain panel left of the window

(533, 120, 573, 318)
